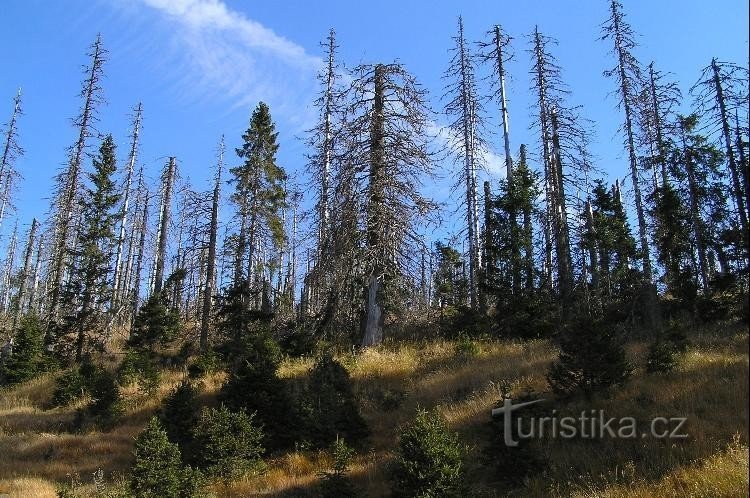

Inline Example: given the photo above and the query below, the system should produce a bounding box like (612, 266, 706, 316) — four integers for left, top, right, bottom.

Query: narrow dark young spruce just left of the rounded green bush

(161, 380, 199, 458)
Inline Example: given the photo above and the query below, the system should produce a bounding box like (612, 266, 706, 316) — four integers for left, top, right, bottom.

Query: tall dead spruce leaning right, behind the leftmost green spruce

(48, 35, 107, 322)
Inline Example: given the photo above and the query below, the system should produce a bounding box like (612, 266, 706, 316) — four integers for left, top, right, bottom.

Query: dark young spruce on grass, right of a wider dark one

(306, 352, 368, 447)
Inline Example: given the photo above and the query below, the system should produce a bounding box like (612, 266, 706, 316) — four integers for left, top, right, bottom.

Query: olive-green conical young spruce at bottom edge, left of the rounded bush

(129, 417, 201, 498)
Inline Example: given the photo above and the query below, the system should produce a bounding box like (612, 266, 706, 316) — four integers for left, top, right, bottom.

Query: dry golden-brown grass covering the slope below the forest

(0, 324, 749, 498)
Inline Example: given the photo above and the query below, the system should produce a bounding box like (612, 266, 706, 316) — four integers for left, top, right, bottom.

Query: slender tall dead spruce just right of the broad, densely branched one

(444, 16, 486, 307)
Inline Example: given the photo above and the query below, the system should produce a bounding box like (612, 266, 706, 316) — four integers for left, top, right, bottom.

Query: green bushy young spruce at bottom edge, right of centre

(393, 410, 464, 497)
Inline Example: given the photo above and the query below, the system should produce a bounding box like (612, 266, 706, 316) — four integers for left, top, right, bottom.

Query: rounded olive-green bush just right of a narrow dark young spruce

(194, 405, 264, 481)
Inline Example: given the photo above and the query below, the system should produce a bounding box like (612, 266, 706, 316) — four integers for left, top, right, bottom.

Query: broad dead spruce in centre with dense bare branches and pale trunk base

(346, 63, 434, 347)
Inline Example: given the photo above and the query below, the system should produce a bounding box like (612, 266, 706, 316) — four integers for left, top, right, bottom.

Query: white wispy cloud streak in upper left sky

(124, 0, 322, 119)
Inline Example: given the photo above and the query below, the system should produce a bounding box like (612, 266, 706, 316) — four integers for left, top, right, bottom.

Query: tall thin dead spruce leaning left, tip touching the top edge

(601, 0, 661, 329)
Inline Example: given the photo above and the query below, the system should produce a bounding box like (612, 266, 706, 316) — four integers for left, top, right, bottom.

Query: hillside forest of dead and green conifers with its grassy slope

(0, 0, 750, 498)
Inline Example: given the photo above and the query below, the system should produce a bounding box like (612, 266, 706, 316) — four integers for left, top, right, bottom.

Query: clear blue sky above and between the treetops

(0, 0, 749, 249)
